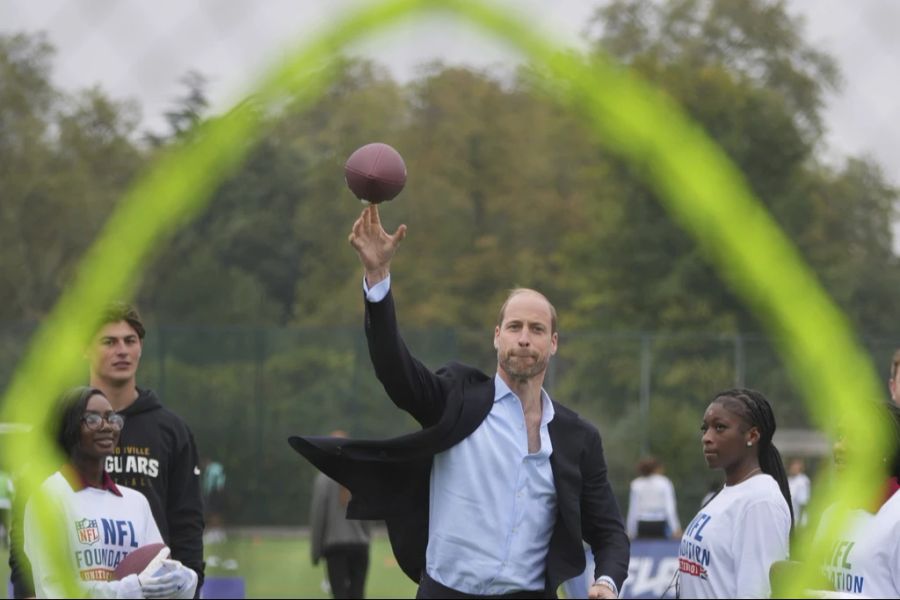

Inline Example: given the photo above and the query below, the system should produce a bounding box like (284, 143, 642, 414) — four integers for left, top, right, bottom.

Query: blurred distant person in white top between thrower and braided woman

(625, 456, 681, 539)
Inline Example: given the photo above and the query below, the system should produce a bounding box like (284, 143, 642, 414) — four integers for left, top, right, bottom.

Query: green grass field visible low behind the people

(0, 535, 416, 598)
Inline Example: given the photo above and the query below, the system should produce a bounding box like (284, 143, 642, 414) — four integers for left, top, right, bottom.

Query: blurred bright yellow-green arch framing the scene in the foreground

(0, 0, 889, 596)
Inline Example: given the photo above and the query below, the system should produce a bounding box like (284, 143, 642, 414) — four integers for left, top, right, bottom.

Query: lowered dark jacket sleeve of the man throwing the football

(581, 429, 631, 590)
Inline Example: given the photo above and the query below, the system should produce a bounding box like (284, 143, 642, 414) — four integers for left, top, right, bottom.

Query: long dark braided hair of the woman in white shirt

(715, 388, 794, 527)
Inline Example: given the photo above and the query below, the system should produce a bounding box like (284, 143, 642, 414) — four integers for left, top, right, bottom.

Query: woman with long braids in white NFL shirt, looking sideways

(678, 389, 793, 598)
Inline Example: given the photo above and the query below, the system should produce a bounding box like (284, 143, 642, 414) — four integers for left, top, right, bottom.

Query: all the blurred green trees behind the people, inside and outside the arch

(0, 0, 900, 524)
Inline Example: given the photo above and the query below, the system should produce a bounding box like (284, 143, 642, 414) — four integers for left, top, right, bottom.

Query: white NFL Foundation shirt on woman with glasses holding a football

(24, 471, 163, 598)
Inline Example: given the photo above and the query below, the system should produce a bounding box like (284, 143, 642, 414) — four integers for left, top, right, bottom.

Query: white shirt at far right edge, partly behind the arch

(830, 494, 900, 598)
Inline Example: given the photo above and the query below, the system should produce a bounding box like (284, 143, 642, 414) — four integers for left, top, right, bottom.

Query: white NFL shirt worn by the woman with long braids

(678, 474, 791, 598)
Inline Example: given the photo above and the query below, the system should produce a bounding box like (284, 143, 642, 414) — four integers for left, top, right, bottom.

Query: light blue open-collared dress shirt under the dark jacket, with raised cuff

(363, 279, 556, 595)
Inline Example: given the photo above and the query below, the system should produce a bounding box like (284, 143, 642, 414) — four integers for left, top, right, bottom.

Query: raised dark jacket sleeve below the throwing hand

(366, 292, 446, 427)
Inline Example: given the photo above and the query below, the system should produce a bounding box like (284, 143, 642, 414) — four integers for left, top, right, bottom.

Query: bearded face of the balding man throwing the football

(494, 292, 558, 381)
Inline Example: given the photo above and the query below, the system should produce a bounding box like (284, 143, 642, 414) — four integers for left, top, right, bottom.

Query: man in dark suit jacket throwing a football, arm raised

(290, 206, 629, 598)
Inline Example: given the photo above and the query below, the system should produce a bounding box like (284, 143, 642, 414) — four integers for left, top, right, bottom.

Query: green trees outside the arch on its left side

(0, 34, 141, 321)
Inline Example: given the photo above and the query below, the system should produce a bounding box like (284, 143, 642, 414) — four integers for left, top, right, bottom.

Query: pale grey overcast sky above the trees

(0, 0, 900, 202)
